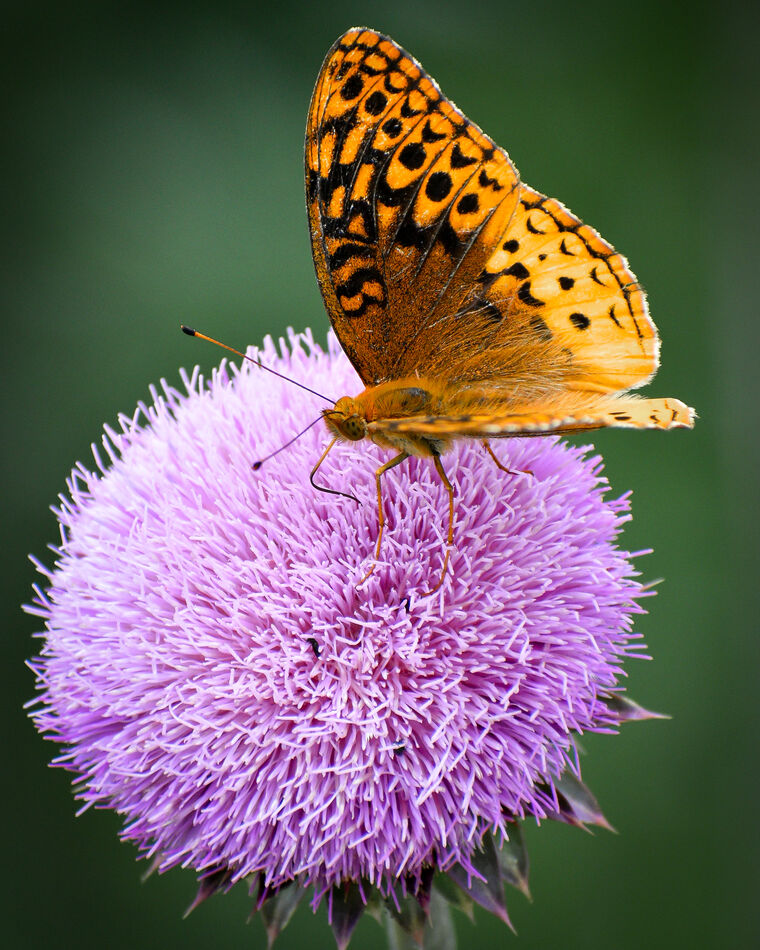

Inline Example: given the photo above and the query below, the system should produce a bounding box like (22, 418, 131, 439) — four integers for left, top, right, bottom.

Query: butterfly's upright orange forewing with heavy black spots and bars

(306, 29, 519, 384)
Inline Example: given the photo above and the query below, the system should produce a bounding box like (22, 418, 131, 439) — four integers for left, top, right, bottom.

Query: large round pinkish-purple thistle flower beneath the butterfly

(28, 334, 660, 946)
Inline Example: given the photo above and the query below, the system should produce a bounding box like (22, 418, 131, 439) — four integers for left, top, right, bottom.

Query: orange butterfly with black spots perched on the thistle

(305, 28, 694, 593)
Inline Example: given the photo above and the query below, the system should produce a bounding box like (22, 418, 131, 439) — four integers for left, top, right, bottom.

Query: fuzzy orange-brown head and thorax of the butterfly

(324, 377, 448, 455)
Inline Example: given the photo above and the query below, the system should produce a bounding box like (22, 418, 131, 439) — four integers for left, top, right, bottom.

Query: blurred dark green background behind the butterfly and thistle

(0, 0, 760, 950)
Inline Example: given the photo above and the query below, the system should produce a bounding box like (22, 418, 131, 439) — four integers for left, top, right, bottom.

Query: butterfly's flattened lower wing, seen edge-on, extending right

(369, 391, 694, 439)
